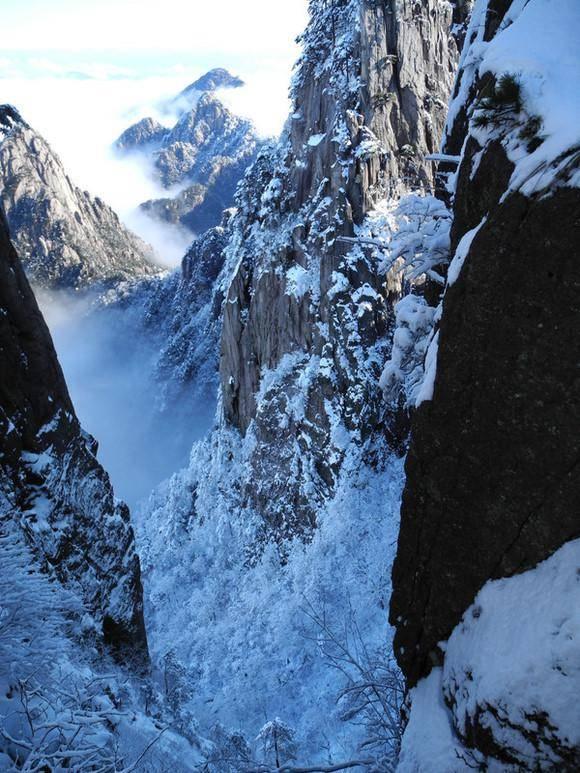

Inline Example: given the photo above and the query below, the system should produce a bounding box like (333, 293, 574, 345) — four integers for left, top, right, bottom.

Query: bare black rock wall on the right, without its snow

(391, 2, 580, 685)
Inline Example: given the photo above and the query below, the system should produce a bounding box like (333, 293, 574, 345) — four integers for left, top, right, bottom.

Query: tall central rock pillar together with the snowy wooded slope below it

(137, 0, 461, 769)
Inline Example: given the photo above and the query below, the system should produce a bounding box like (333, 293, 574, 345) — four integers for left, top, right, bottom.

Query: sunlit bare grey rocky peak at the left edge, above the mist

(0, 105, 158, 290)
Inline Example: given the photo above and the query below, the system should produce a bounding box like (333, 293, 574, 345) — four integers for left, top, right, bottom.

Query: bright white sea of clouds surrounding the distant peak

(0, 52, 291, 267)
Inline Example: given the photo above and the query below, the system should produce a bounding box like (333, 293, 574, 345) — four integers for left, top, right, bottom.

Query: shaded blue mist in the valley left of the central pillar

(36, 289, 215, 508)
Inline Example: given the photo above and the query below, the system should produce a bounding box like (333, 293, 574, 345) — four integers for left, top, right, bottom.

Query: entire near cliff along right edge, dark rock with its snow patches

(391, 0, 580, 770)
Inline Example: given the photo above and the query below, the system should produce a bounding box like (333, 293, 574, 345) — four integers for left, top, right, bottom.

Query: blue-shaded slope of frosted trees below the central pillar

(137, 430, 402, 770)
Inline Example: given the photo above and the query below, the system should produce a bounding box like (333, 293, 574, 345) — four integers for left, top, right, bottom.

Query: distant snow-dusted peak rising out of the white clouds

(115, 70, 261, 234)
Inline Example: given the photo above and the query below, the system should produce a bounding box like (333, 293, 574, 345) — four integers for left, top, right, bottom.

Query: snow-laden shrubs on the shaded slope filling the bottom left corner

(0, 520, 204, 773)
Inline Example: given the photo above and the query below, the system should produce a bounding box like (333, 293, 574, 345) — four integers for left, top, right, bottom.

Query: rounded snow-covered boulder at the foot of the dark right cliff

(443, 540, 580, 770)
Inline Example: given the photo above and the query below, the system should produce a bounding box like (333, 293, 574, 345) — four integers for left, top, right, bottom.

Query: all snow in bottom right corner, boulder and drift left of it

(398, 540, 580, 773)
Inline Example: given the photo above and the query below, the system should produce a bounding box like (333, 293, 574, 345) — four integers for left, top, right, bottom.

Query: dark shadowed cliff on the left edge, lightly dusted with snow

(0, 208, 147, 664)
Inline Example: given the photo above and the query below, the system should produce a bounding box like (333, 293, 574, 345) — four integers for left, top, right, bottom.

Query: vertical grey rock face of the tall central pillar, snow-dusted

(220, 0, 456, 544)
